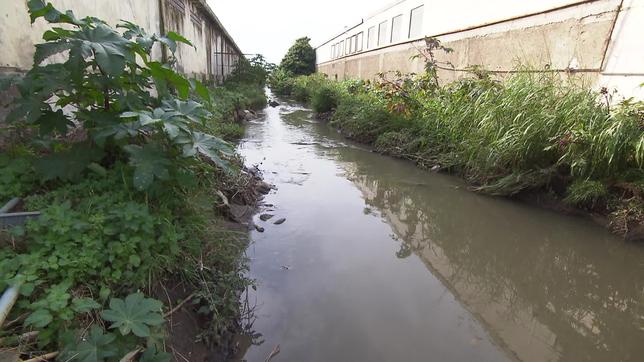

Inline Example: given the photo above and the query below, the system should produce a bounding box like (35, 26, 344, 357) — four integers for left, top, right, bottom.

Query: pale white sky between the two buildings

(208, 0, 393, 64)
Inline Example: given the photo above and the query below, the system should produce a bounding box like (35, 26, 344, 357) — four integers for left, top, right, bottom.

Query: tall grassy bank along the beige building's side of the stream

(269, 66, 644, 239)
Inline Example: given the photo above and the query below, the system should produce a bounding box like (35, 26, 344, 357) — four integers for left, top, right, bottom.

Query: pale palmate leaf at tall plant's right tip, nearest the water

(176, 132, 233, 171)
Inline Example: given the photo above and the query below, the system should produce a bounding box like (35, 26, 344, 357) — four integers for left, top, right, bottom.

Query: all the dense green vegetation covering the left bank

(0, 0, 269, 362)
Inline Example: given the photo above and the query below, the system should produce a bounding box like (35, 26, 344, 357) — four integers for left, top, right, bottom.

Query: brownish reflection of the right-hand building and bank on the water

(332, 141, 644, 361)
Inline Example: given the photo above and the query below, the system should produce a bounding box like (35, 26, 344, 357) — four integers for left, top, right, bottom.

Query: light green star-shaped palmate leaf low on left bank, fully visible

(101, 293, 165, 337)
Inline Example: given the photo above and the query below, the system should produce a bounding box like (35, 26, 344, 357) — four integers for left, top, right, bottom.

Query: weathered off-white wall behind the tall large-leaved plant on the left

(0, 0, 243, 82)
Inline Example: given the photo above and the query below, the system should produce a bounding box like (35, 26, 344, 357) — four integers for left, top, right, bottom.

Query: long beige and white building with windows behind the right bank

(316, 0, 644, 99)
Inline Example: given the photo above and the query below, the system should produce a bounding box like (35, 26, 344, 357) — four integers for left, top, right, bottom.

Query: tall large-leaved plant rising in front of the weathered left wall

(9, 0, 234, 190)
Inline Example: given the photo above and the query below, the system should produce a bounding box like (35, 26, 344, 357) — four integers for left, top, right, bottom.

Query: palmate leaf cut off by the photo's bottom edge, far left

(58, 325, 118, 362)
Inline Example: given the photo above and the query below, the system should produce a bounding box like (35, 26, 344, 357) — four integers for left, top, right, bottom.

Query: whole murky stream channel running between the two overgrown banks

(240, 99, 644, 361)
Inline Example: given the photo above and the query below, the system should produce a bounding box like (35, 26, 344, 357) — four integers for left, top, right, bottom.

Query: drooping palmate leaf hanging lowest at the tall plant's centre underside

(124, 144, 172, 190)
